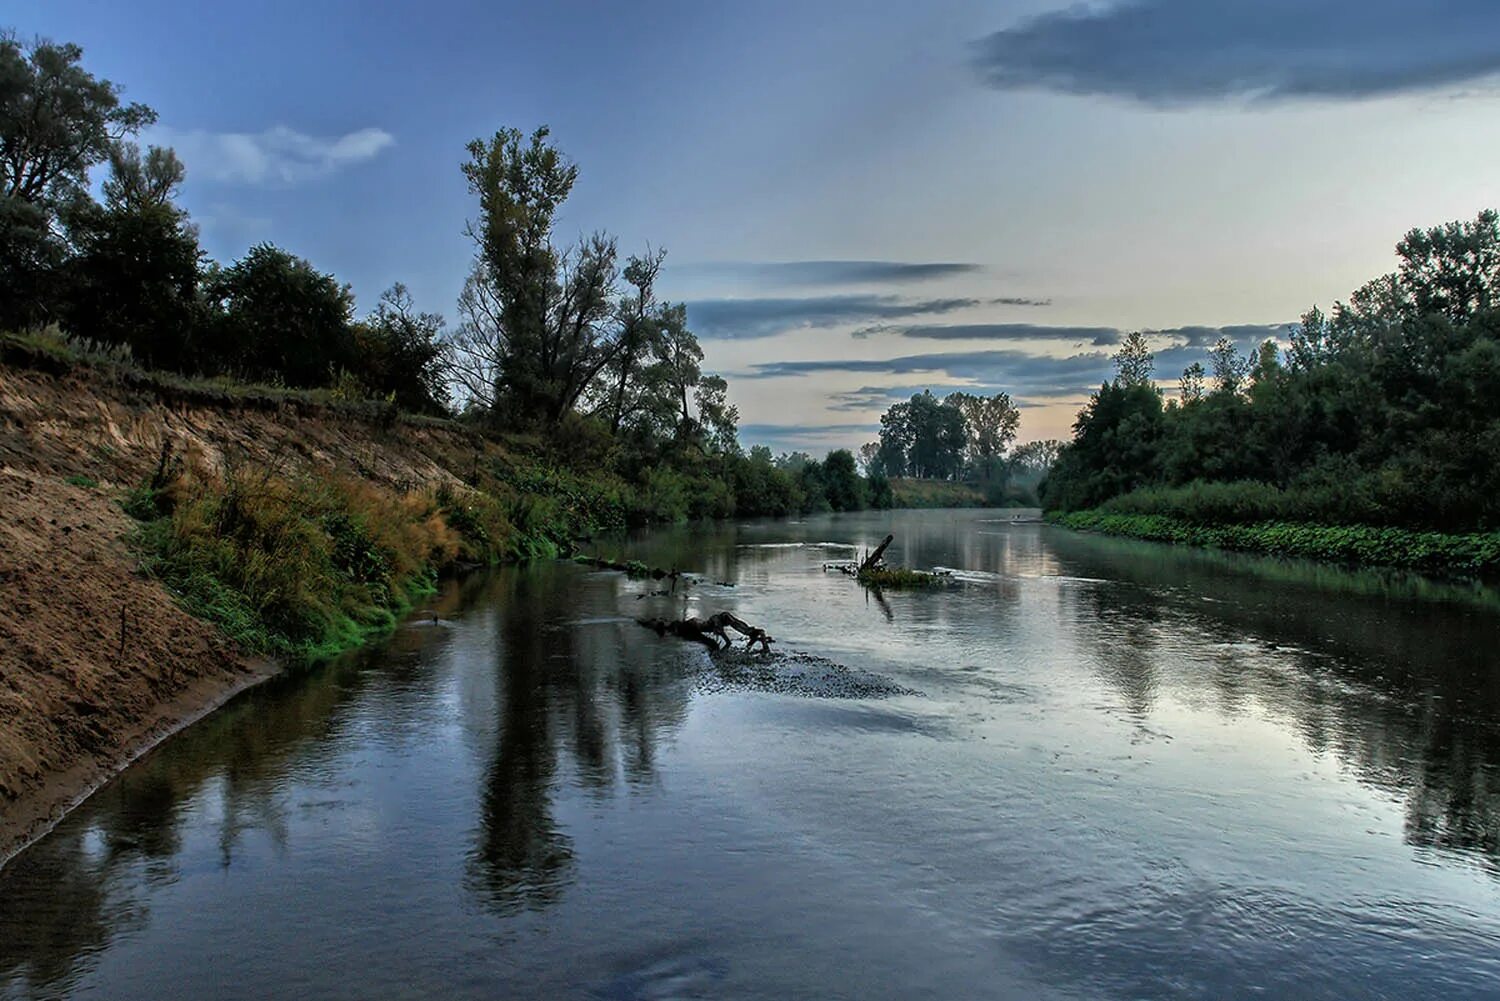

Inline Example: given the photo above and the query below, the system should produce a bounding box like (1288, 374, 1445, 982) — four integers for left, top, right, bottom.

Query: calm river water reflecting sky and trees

(0, 512, 1500, 1001)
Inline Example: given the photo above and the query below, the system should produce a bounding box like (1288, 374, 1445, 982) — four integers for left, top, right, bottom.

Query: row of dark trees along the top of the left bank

(0, 35, 1032, 521)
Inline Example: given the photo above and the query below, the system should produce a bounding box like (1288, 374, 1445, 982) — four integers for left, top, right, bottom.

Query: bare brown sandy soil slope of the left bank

(0, 363, 483, 861)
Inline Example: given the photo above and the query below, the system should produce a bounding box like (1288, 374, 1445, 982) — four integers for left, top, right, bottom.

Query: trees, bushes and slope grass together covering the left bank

(0, 33, 1032, 659)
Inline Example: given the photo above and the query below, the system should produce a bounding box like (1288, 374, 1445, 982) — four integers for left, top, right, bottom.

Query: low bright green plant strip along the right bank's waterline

(1047, 510, 1500, 578)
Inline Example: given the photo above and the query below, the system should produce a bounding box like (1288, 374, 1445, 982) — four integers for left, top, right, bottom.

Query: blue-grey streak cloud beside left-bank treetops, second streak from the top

(687, 294, 986, 339)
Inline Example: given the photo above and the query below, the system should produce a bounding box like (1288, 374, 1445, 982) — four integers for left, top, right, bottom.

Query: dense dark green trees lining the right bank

(1043, 212, 1500, 531)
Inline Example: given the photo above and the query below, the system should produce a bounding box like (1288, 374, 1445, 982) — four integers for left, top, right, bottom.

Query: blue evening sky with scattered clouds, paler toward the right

(17, 0, 1500, 455)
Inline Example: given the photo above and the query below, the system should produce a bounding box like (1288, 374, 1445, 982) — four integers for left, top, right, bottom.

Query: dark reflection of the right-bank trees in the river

(1070, 540, 1500, 876)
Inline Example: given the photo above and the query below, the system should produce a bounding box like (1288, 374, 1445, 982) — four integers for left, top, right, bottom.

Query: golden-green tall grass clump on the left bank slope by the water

(125, 468, 582, 660)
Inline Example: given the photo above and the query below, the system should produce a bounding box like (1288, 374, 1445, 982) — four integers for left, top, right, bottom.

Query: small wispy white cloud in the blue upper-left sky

(150, 125, 396, 185)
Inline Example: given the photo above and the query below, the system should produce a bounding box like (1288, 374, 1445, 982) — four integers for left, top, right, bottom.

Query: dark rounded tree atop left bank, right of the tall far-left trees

(204, 243, 359, 386)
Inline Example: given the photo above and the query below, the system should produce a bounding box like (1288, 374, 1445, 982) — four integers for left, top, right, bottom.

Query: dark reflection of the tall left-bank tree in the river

(470, 566, 689, 911)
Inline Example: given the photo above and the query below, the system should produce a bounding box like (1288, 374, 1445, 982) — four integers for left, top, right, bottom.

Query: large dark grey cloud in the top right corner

(974, 0, 1500, 105)
